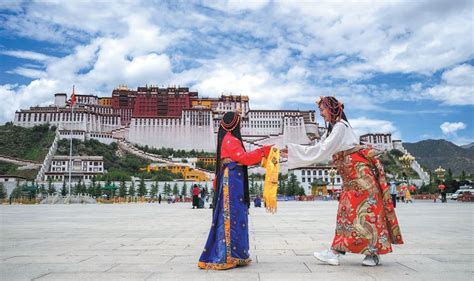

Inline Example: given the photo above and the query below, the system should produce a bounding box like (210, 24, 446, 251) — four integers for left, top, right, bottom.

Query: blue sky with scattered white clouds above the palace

(0, 0, 474, 145)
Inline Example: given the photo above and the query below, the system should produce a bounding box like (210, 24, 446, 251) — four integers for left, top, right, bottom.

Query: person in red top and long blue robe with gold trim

(198, 112, 271, 270)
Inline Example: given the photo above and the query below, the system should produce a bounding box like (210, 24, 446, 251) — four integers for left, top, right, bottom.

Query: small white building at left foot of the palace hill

(45, 156, 104, 182)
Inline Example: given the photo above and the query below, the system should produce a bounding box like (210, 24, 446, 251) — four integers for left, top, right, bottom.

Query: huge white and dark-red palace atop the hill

(14, 85, 319, 152)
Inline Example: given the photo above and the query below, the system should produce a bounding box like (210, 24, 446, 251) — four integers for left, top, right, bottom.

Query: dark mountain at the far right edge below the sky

(403, 140, 474, 175)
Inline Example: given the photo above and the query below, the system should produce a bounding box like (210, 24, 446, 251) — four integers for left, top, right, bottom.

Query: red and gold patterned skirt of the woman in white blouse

(332, 146, 403, 254)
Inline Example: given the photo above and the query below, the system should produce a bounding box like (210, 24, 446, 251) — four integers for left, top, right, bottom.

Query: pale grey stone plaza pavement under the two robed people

(0, 201, 474, 281)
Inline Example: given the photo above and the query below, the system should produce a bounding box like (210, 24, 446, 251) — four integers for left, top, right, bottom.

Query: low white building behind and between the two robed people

(290, 165, 342, 195)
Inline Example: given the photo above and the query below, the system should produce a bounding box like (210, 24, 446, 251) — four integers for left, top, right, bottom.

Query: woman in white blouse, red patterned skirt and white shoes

(282, 97, 403, 266)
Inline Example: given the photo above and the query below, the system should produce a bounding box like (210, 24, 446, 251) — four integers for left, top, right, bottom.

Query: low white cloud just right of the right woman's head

(349, 117, 401, 139)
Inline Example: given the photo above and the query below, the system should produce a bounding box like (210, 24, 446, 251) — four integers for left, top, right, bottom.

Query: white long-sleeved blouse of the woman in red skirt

(288, 120, 359, 169)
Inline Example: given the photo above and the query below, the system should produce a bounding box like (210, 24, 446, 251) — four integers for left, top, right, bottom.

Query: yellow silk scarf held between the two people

(262, 147, 280, 214)
